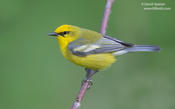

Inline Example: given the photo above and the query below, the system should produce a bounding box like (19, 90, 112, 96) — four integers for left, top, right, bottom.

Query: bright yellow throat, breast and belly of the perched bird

(58, 37, 116, 70)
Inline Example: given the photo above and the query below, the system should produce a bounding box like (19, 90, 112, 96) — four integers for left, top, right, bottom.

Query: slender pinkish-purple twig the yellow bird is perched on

(72, 0, 114, 109)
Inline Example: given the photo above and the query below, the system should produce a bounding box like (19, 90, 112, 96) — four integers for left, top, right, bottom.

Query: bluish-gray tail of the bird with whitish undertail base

(113, 45, 160, 55)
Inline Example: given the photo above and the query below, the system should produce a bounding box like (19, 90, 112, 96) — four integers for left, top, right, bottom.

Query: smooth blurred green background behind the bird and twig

(0, 0, 175, 109)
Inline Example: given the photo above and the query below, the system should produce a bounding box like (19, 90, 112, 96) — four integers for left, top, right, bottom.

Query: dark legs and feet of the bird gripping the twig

(82, 68, 97, 88)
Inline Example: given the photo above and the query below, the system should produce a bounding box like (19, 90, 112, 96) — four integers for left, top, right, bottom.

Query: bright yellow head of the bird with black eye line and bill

(49, 25, 80, 43)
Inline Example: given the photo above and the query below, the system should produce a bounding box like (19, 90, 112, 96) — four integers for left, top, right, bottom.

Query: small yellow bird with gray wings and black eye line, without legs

(49, 25, 160, 78)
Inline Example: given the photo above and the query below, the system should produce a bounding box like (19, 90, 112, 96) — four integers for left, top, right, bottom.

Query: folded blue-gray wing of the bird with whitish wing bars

(68, 36, 133, 56)
